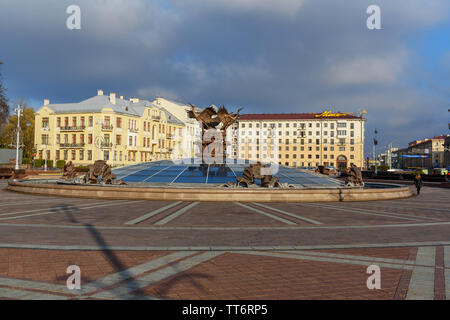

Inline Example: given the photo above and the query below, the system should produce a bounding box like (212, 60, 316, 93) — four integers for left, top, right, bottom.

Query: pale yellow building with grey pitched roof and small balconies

(35, 90, 184, 167)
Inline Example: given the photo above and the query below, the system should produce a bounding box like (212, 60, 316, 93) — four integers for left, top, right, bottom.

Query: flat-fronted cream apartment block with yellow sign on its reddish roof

(233, 111, 366, 169)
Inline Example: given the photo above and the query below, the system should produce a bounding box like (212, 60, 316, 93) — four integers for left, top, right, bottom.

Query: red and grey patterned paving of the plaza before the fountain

(0, 182, 450, 300)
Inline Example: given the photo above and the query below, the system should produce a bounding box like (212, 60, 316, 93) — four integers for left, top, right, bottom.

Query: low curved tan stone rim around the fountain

(7, 181, 413, 202)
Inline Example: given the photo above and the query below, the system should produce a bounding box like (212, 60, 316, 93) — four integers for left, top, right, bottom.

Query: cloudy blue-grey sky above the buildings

(0, 0, 450, 153)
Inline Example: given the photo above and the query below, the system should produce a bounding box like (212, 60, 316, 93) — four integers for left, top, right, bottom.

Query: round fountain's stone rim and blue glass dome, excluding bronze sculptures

(7, 161, 412, 202)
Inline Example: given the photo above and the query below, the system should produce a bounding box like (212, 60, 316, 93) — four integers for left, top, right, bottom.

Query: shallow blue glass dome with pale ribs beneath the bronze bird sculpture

(113, 159, 343, 188)
